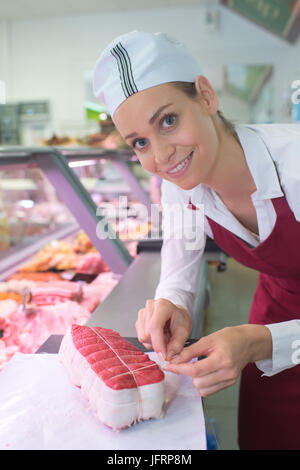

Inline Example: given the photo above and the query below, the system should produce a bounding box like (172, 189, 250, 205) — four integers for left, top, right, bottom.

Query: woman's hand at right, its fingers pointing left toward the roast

(164, 325, 272, 397)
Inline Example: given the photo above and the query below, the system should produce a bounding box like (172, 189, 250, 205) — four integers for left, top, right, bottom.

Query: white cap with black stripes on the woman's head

(93, 31, 201, 116)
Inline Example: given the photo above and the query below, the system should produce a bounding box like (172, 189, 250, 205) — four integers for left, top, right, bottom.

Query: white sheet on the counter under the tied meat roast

(0, 353, 206, 450)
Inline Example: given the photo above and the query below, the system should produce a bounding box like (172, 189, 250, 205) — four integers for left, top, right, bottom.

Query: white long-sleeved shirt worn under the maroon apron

(155, 124, 300, 376)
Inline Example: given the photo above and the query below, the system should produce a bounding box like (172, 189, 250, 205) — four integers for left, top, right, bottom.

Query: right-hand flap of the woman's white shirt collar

(235, 124, 283, 199)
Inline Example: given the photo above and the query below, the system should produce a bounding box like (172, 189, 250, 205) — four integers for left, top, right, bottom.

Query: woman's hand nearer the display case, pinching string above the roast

(135, 299, 192, 361)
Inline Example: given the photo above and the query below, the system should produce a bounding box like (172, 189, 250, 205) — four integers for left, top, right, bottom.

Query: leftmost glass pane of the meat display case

(0, 167, 74, 251)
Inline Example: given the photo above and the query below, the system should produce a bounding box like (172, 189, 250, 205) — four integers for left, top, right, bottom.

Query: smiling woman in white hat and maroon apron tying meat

(94, 31, 300, 449)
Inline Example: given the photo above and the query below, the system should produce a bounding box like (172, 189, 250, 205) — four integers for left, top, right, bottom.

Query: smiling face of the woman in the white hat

(114, 76, 219, 189)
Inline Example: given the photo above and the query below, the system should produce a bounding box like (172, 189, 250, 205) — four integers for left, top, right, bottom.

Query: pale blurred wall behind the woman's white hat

(0, 6, 293, 136)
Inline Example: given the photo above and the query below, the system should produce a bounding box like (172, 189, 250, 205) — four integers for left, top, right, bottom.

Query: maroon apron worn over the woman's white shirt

(207, 188, 300, 450)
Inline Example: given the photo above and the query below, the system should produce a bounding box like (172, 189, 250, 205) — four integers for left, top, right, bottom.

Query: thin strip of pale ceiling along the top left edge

(0, 0, 219, 20)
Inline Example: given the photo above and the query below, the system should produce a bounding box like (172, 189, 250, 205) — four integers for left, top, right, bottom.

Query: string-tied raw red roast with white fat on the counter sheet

(58, 324, 164, 430)
